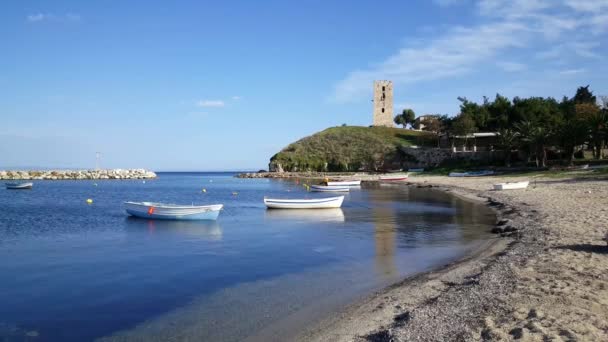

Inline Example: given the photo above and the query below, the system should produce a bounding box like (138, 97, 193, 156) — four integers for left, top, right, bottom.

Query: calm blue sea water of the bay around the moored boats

(0, 173, 494, 341)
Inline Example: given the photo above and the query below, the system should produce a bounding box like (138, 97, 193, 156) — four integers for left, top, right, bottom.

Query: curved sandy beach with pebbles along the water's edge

(297, 176, 608, 341)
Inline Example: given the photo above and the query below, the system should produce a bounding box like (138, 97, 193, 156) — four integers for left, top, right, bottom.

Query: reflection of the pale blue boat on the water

(125, 216, 222, 241)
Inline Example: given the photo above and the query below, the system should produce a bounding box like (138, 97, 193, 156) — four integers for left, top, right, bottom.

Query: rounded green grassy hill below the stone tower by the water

(270, 126, 436, 171)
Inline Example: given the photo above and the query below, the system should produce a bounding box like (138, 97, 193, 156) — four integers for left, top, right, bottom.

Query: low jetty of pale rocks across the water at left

(0, 169, 156, 180)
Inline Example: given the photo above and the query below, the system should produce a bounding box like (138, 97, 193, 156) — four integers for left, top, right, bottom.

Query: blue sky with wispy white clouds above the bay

(0, 0, 608, 170)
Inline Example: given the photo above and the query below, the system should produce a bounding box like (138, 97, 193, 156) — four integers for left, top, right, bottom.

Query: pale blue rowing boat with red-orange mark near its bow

(125, 202, 224, 220)
